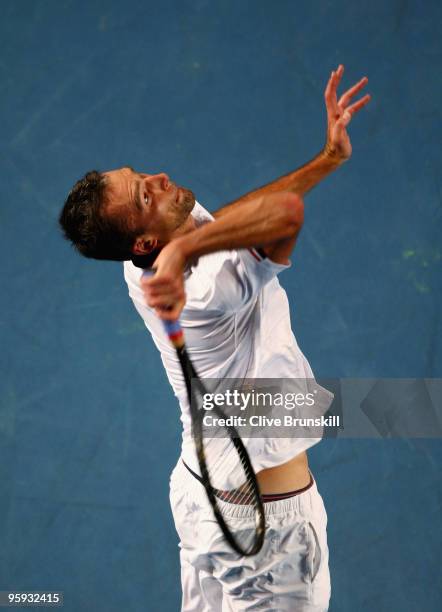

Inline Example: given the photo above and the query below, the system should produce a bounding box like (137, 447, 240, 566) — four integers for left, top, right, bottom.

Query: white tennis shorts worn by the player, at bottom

(170, 459, 330, 612)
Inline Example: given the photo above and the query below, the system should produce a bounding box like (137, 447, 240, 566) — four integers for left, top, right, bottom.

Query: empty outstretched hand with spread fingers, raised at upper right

(324, 64, 370, 160)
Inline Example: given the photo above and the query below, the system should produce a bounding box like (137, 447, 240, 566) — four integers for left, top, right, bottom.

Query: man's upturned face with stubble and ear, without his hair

(104, 166, 195, 254)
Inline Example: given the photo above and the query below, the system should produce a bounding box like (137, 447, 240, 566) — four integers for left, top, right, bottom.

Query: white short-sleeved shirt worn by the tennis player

(124, 202, 333, 489)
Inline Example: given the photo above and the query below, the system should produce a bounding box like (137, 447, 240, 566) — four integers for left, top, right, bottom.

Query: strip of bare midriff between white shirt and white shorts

(256, 451, 310, 495)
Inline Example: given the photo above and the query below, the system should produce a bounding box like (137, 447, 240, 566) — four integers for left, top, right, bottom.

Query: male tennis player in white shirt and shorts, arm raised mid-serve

(60, 65, 370, 612)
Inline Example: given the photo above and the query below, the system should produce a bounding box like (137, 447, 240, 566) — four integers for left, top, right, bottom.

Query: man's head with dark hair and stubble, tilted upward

(59, 166, 195, 261)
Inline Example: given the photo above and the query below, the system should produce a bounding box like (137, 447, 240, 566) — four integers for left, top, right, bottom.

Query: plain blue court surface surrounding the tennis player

(0, 0, 442, 612)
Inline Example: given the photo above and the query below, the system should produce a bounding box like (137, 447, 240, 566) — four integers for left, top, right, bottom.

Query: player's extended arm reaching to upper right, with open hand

(214, 65, 370, 218)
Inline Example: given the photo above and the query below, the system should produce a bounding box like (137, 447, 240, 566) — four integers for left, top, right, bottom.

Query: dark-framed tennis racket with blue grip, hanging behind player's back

(143, 270, 265, 557)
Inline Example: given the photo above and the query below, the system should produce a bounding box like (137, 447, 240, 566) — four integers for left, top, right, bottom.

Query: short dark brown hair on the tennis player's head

(59, 170, 142, 261)
